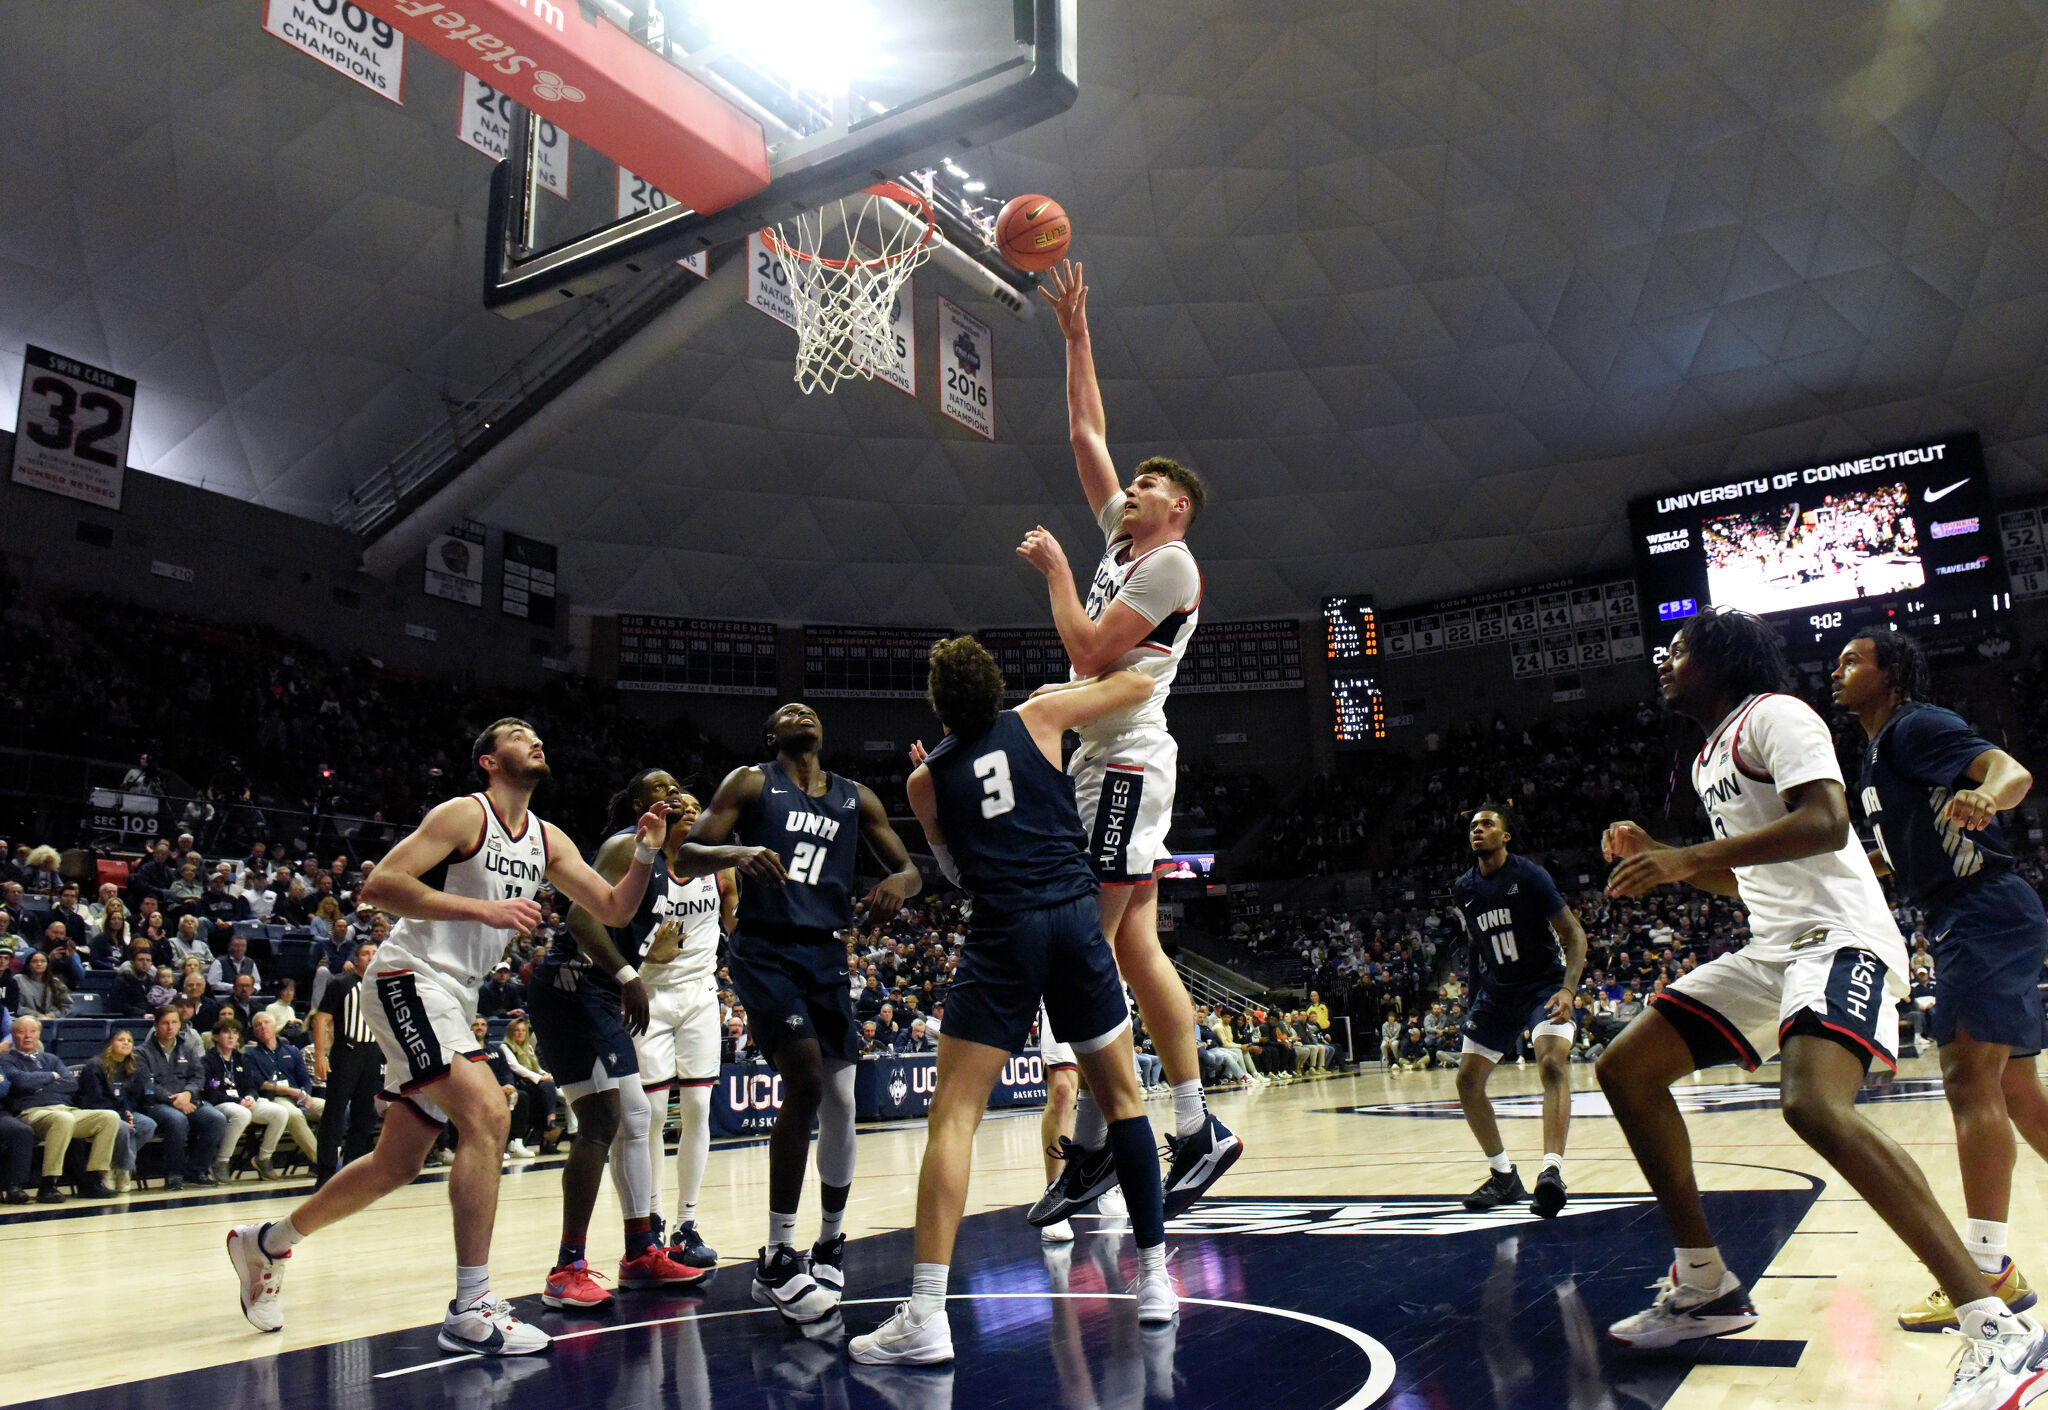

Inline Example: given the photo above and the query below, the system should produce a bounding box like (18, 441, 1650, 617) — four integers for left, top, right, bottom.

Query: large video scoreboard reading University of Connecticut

(1628, 432, 2007, 639)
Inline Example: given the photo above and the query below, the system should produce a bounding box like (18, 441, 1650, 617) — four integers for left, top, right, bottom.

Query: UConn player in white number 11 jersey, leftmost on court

(227, 719, 668, 1357)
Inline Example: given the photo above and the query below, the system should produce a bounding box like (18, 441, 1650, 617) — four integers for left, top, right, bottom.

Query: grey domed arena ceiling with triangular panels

(0, 0, 2048, 625)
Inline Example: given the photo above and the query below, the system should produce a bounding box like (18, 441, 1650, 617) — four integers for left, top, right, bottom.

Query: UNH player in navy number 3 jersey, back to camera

(848, 637, 1180, 1365)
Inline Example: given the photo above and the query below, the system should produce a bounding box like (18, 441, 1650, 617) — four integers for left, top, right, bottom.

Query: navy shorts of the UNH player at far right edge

(1927, 871, 2048, 1058)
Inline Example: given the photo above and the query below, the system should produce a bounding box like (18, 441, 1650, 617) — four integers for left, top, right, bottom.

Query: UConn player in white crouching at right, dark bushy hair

(1595, 609, 2048, 1410)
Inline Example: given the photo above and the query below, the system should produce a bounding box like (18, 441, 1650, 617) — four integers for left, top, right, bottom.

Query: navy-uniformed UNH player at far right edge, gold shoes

(1835, 631, 2048, 1332)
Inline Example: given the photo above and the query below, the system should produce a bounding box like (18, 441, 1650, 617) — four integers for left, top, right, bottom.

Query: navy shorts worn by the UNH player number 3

(946, 896, 1130, 1053)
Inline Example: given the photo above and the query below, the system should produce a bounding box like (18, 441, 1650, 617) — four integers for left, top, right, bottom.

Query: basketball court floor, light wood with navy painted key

(0, 1060, 2044, 1410)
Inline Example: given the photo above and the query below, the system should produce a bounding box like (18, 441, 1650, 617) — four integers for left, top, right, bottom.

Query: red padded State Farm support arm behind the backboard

(352, 0, 768, 213)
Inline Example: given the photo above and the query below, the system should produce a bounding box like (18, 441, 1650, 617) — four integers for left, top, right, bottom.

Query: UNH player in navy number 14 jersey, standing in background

(1450, 803, 1585, 1219)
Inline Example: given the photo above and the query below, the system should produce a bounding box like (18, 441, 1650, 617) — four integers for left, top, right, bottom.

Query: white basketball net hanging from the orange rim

(762, 182, 940, 396)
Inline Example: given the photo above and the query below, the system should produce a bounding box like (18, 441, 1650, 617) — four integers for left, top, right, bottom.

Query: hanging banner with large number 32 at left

(14, 344, 135, 508)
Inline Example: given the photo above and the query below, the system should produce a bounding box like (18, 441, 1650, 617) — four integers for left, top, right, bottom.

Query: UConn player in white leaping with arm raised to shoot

(1018, 262, 1243, 1224)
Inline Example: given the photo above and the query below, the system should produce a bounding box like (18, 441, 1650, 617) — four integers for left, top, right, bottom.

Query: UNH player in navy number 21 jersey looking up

(676, 705, 924, 1322)
